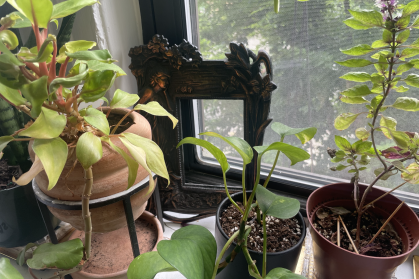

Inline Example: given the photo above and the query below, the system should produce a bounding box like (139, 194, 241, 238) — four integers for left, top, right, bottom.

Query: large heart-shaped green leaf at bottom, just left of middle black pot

(157, 225, 217, 279)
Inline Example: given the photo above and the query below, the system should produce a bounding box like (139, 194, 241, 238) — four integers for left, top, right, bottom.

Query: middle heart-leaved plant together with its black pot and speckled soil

(128, 123, 317, 279)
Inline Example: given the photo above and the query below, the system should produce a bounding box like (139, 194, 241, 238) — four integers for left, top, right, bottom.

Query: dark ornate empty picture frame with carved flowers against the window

(129, 35, 276, 219)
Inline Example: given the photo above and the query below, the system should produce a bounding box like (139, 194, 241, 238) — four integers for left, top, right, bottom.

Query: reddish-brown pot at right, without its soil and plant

(307, 183, 419, 279)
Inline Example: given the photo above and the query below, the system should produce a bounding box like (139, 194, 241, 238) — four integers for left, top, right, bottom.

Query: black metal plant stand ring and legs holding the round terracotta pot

(32, 176, 164, 258)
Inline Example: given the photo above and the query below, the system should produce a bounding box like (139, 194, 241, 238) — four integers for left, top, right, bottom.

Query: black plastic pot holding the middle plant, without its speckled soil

(215, 191, 306, 279)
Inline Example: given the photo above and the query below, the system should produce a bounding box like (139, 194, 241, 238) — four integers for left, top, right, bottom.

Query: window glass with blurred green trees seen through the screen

(197, 0, 419, 193)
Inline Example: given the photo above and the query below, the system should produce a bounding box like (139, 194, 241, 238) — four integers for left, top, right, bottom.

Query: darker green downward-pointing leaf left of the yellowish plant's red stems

(20, 76, 48, 118)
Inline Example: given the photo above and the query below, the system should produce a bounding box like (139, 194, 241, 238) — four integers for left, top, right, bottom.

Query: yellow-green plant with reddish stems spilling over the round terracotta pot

(0, 0, 177, 276)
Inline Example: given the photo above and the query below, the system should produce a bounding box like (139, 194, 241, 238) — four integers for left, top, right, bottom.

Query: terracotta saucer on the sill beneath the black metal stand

(70, 211, 163, 279)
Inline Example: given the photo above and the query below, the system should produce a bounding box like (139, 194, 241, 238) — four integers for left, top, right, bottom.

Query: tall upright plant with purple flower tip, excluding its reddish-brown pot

(329, 0, 419, 250)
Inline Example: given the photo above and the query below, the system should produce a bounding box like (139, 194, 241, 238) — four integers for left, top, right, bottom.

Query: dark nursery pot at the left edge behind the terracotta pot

(0, 184, 59, 248)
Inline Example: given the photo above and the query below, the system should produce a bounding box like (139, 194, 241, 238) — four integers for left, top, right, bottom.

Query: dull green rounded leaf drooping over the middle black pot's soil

(256, 185, 300, 219)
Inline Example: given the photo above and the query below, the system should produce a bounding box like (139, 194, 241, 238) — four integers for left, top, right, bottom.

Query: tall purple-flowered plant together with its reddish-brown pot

(307, 0, 419, 279)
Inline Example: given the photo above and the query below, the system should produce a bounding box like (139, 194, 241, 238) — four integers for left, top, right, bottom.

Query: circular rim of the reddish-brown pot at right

(307, 182, 419, 260)
